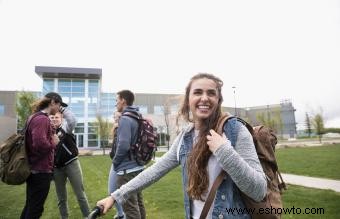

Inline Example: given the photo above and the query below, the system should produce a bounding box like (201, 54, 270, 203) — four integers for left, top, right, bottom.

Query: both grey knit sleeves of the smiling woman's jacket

(111, 126, 267, 203)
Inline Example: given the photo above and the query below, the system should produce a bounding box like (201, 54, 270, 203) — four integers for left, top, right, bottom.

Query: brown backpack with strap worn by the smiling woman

(200, 114, 286, 219)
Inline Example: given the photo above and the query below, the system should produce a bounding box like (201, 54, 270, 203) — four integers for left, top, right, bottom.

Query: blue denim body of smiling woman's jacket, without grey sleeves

(179, 119, 250, 219)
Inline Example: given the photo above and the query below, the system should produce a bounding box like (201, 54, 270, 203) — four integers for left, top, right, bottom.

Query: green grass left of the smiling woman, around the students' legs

(0, 155, 184, 219)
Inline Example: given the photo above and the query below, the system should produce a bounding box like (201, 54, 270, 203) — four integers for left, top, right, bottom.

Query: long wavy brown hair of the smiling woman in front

(177, 73, 223, 200)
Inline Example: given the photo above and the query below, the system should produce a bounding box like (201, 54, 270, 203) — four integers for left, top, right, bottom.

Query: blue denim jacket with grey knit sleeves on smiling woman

(111, 119, 267, 219)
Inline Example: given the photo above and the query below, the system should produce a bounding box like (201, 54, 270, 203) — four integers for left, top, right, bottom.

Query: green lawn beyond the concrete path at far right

(276, 144, 340, 180)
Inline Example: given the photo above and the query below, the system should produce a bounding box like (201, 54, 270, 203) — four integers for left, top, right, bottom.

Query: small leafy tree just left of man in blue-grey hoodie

(95, 115, 113, 155)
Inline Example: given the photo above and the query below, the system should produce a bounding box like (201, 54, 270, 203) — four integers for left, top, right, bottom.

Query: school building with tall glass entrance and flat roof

(0, 66, 296, 148)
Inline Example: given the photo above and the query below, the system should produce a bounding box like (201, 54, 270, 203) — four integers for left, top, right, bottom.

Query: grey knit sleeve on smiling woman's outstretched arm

(111, 130, 183, 204)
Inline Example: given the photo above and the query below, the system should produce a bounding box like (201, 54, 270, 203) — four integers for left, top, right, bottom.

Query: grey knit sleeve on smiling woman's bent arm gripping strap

(214, 125, 267, 201)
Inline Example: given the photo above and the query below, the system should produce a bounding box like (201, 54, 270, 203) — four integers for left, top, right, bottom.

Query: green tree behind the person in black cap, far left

(16, 91, 38, 129)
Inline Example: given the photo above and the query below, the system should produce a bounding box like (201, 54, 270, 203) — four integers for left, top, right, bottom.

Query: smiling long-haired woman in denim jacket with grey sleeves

(97, 73, 267, 219)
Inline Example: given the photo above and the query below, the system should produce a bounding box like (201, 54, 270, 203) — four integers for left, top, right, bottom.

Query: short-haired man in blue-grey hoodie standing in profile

(112, 90, 146, 218)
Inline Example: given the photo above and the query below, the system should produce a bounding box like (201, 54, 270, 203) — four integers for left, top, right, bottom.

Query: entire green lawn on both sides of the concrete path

(0, 145, 340, 219)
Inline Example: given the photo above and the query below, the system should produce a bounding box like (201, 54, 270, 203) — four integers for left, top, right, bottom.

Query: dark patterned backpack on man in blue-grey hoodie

(122, 112, 157, 166)
